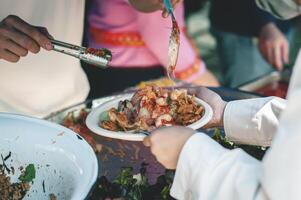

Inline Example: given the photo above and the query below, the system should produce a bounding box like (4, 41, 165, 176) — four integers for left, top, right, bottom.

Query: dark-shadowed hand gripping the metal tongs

(0, 15, 52, 62)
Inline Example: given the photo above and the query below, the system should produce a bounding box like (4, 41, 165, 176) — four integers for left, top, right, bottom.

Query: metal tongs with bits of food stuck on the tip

(50, 40, 112, 69)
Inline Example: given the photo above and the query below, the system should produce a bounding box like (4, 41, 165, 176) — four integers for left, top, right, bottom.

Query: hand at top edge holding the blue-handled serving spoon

(129, 0, 181, 18)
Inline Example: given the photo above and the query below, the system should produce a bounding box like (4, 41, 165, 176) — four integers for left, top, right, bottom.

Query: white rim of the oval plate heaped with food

(86, 94, 213, 141)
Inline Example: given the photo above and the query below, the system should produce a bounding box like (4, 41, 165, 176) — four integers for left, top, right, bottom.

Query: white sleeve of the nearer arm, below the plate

(171, 133, 261, 200)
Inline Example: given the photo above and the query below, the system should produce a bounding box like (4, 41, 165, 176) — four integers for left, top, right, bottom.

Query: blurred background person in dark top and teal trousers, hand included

(210, 0, 291, 87)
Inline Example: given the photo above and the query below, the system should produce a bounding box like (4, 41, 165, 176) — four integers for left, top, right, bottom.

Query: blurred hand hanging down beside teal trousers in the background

(259, 23, 289, 70)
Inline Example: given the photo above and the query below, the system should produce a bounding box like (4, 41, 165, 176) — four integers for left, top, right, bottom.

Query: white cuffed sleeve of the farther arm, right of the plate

(224, 97, 286, 146)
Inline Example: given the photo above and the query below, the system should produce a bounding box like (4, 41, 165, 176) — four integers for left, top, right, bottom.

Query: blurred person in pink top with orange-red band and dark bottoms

(85, 0, 218, 97)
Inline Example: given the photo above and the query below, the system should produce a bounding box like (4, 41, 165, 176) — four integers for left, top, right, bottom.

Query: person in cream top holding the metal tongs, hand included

(0, 0, 89, 117)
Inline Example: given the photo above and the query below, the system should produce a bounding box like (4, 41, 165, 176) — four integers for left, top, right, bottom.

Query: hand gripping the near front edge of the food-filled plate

(143, 126, 195, 169)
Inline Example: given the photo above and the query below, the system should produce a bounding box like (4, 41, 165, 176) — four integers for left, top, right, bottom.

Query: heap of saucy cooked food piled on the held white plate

(99, 86, 204, 132)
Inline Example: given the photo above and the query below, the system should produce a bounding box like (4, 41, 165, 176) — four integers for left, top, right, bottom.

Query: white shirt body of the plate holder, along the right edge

(262, 51, 301, 200)
